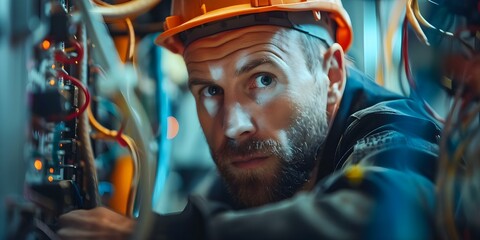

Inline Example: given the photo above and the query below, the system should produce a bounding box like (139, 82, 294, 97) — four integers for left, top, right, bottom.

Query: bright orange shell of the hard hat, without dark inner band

(155, 0, 353, 53)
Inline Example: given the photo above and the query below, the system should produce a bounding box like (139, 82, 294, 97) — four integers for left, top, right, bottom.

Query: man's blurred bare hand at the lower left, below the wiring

(57, 207, 135, 239)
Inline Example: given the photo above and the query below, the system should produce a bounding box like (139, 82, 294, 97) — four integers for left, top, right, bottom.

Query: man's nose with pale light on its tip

(224, 103, 255, 140)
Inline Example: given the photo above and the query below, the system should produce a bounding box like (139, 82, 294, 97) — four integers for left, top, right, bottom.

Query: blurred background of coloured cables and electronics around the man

(0, 0, 480, 239)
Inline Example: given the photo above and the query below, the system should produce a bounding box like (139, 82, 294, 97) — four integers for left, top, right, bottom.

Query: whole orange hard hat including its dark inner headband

(155, 0, 353, 53)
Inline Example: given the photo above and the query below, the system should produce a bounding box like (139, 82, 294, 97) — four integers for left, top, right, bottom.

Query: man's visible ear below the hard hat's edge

(323, 43, 347, 120)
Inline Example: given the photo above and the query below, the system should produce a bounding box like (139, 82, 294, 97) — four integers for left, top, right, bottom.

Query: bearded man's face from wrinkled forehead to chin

(184, 26, 328, 207)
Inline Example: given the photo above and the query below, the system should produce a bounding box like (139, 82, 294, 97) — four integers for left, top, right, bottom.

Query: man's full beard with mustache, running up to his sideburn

(210, 95, 328, 208)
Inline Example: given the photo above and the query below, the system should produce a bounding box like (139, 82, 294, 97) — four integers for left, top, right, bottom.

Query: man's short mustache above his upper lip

(215, 138, 282, 159)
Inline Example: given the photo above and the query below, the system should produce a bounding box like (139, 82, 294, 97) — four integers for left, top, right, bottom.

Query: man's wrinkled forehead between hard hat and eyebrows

(184, 25, 299, 65)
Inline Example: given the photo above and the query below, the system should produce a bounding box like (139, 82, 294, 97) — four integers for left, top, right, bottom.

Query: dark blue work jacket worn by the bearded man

(149, 69, 440, 240)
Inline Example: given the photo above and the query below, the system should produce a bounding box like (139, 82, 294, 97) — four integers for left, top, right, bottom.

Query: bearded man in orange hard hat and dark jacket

(58, 0, 439, 239)
